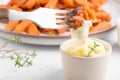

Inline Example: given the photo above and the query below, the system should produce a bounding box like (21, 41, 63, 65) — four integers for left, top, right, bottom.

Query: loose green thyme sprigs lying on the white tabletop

(0, 35, 37, 68)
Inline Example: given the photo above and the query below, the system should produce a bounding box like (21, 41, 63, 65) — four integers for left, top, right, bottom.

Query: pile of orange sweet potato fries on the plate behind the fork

(0, 0, 111, 36)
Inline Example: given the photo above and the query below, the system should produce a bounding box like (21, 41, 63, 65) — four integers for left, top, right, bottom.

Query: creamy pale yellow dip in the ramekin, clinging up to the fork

(66, 20, 107, 57)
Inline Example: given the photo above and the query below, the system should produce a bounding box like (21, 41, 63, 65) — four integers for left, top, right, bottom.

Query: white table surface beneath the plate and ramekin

(0, 29, 120, 80)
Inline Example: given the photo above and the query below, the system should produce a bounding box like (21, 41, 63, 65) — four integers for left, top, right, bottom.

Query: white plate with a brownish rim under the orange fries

(0, 0, 120, 45)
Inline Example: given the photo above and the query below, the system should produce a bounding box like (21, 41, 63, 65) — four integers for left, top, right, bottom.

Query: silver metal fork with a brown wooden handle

(0, 8, 72, 29)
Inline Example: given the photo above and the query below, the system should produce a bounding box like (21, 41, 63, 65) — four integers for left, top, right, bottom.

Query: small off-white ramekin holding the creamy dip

(60, 38, 112, 80)
